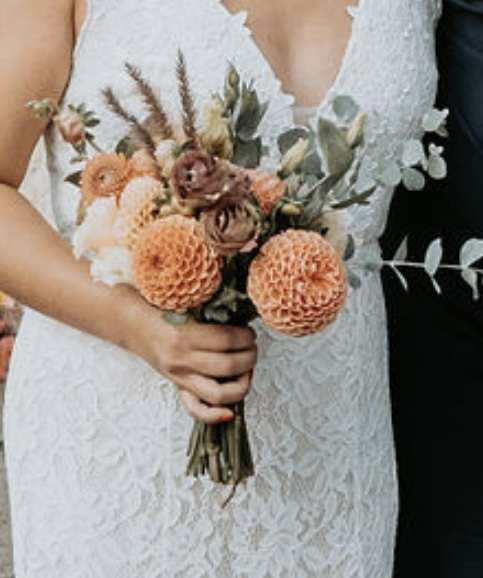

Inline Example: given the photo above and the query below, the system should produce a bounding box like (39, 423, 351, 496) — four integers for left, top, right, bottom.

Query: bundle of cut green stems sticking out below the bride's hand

(186, 400, 254, 507)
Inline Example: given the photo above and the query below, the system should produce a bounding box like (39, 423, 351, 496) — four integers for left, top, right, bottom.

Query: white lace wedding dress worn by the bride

(5, 0, 438, 578)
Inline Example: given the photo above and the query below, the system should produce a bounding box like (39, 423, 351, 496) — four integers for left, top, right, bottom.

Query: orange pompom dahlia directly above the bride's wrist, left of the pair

(132, 215, 222, 312)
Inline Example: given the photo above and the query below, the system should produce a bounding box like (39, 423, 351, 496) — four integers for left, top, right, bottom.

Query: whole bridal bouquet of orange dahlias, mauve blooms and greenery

(29, 54, 448, 498)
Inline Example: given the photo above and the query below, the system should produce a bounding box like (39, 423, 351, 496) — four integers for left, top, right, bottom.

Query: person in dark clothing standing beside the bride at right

(383, 0, 483, 578)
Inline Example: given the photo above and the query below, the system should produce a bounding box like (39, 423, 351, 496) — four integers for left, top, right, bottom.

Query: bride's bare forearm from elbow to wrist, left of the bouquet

(0, 185, 142, 346)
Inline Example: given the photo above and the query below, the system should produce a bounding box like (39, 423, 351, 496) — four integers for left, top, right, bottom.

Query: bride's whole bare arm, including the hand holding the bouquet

(0, 0, 256, 422)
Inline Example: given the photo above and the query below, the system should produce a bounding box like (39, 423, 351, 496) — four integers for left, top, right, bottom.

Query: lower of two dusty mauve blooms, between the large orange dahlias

(200, 195, 260, 257)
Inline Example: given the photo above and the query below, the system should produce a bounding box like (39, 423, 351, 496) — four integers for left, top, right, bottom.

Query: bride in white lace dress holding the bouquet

(0, 0, 439, 578)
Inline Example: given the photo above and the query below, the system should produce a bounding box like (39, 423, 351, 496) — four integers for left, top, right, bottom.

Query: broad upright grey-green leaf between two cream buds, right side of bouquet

(317, 118, 354, 176)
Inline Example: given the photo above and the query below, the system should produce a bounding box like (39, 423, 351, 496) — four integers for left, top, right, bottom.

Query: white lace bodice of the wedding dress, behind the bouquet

(48, 0, 439, 241)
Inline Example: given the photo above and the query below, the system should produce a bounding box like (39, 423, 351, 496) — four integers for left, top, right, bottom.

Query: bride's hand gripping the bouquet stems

(117, 286, 257, 423)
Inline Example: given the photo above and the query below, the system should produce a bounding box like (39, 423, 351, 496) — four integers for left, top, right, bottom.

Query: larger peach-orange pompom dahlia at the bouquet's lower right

(248, 229, 347, 337)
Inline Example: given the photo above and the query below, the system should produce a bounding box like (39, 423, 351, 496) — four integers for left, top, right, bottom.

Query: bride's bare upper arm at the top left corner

(0, 0, 77, 184)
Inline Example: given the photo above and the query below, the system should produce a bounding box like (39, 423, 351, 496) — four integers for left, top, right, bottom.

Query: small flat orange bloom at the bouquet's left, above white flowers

(80, 153, 132, 205)
